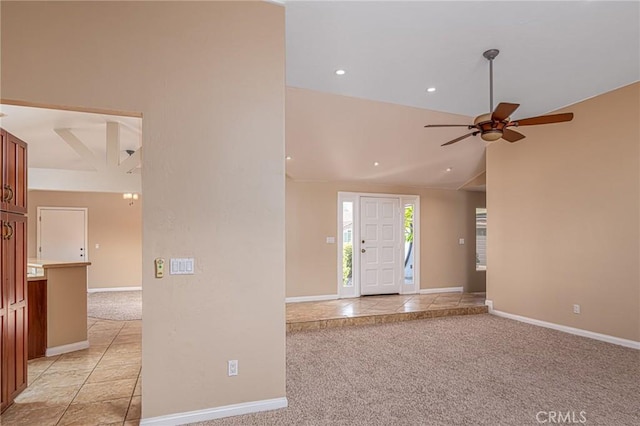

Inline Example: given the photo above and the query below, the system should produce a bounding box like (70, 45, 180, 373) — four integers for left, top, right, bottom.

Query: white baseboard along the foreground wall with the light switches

(140, 397, 288, 426)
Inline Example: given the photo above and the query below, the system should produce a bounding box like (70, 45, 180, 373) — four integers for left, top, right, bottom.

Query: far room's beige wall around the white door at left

(28, 191, 142, 288)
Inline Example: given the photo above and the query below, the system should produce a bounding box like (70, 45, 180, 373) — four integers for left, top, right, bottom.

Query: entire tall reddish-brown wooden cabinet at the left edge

(0, 130, 28, 411)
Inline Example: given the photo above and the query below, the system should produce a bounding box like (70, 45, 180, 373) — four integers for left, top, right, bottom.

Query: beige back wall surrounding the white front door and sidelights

(286, 179, 485, 297)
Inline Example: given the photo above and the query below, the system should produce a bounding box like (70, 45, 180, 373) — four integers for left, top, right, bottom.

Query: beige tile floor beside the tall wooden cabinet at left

(0, 318, 142, 426)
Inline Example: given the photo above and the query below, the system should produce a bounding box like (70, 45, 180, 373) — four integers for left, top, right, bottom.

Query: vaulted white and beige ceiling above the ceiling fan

(286, 1, 640, 188)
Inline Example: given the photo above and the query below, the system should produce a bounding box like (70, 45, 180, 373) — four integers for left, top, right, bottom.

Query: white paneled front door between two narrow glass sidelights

(354, 197, 402, 295)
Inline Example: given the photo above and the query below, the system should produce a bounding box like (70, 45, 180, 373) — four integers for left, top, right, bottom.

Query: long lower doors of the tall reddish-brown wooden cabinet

(2, 213, 28, 401)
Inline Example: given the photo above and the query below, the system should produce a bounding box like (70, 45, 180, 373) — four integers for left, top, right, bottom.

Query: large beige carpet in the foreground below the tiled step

(202, 314, 640, 426)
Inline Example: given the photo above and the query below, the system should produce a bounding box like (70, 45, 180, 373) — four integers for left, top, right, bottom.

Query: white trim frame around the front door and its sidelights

(336, 191, 421, 299)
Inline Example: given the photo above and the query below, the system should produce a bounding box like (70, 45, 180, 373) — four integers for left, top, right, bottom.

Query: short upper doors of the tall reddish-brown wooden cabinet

(1, 131, 27, 213)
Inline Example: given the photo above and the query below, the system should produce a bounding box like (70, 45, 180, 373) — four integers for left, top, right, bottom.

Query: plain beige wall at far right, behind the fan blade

(487, 83, 640, 341)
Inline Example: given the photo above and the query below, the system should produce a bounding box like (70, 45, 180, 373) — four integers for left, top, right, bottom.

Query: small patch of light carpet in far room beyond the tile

(87, 291, 142, 321)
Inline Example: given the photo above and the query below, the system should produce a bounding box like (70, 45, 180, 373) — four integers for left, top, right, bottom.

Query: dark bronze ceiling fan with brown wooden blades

(424, 49, 573, 146)
